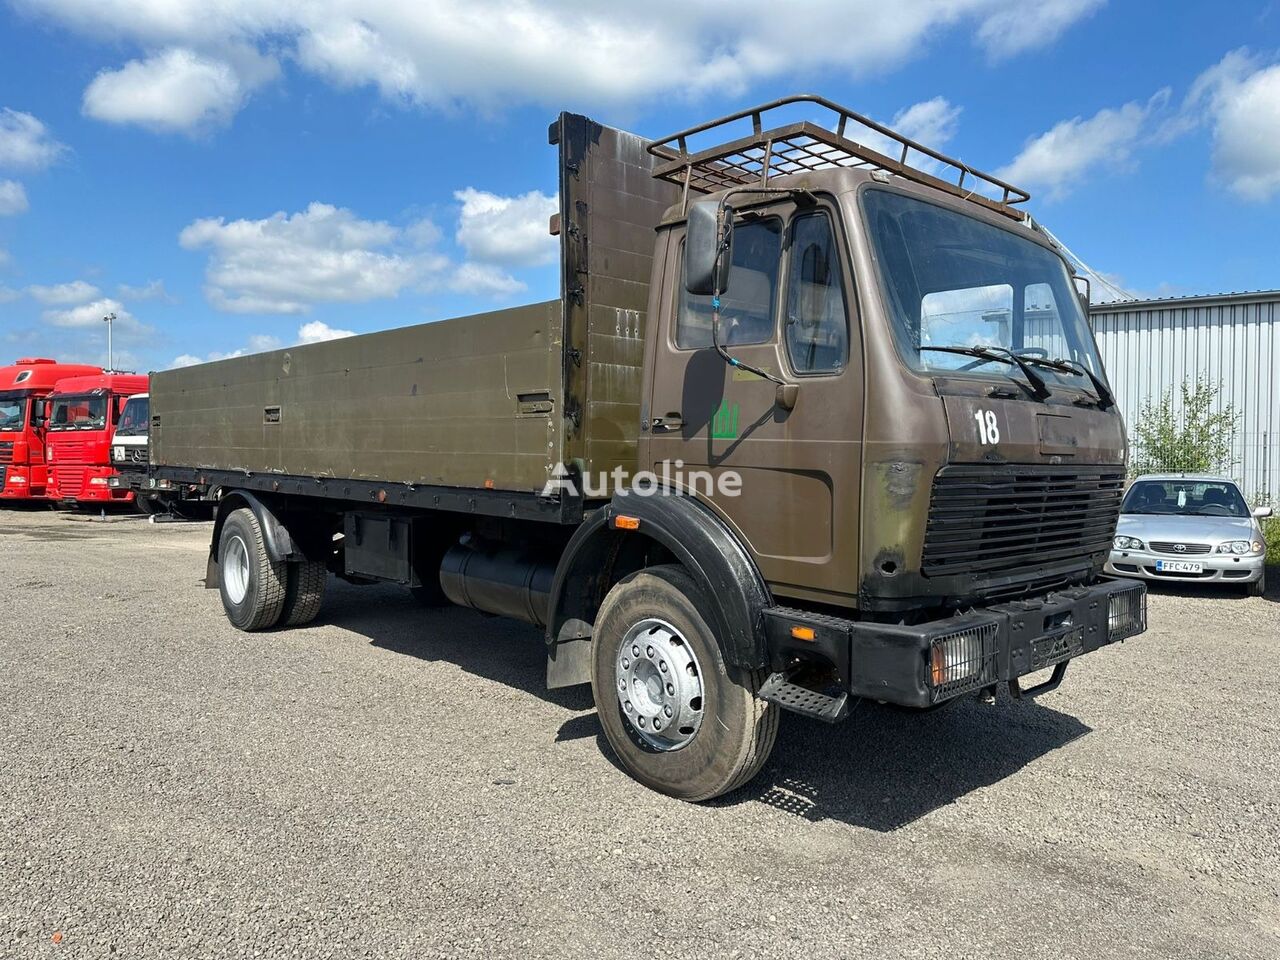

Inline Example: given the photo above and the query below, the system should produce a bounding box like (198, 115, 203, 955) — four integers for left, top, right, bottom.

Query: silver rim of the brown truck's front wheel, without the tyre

(614, 618, 703, 753)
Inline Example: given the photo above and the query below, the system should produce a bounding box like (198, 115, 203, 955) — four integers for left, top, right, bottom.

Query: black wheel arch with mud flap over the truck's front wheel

(547, 493, 772, 686)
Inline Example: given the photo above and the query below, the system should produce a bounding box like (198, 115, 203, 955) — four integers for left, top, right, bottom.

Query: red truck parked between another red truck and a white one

(46, 372, 148, 506)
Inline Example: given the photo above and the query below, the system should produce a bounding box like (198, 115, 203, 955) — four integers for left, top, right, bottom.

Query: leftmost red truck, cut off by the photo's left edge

(0, 357, 102, 500)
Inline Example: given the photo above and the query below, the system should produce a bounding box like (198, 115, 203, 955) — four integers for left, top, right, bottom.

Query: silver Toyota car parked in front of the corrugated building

(1106, 474, 1271, 596)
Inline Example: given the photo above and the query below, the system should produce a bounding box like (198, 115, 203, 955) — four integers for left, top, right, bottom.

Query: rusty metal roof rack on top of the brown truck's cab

(649, 93, 1030, 220)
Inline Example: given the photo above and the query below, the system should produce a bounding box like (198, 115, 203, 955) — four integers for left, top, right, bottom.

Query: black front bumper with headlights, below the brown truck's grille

(764, 580, 1147, 708)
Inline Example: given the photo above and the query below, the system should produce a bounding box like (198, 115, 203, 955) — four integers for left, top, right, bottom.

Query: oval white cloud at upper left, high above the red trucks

(83, 47, 259, 132)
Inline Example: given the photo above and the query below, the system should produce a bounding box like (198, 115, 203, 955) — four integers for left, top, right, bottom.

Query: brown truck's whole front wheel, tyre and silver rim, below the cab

(591, 566, 778, 801)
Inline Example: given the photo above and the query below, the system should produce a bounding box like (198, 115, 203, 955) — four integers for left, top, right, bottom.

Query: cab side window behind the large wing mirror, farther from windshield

(676, 218, 782, 349)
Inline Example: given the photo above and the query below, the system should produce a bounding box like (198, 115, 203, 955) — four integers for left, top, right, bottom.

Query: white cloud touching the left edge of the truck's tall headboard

(453, 187, 559, 266)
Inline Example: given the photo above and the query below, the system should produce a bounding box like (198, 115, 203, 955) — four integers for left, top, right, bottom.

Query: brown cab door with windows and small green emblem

(640, 202, 863, 605)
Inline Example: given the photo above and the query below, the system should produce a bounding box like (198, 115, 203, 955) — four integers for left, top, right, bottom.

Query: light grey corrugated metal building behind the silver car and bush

(1091, 291, 1280, 503)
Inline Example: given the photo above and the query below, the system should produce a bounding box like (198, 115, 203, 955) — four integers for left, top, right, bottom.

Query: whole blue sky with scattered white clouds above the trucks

(0, 0, 1280, 370)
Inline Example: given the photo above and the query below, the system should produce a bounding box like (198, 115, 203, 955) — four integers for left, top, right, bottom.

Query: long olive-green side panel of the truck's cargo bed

(151, 301, 564, 492)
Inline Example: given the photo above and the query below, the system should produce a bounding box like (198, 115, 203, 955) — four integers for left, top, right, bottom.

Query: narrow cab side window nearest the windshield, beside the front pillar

(786, 212, 849, 374)
